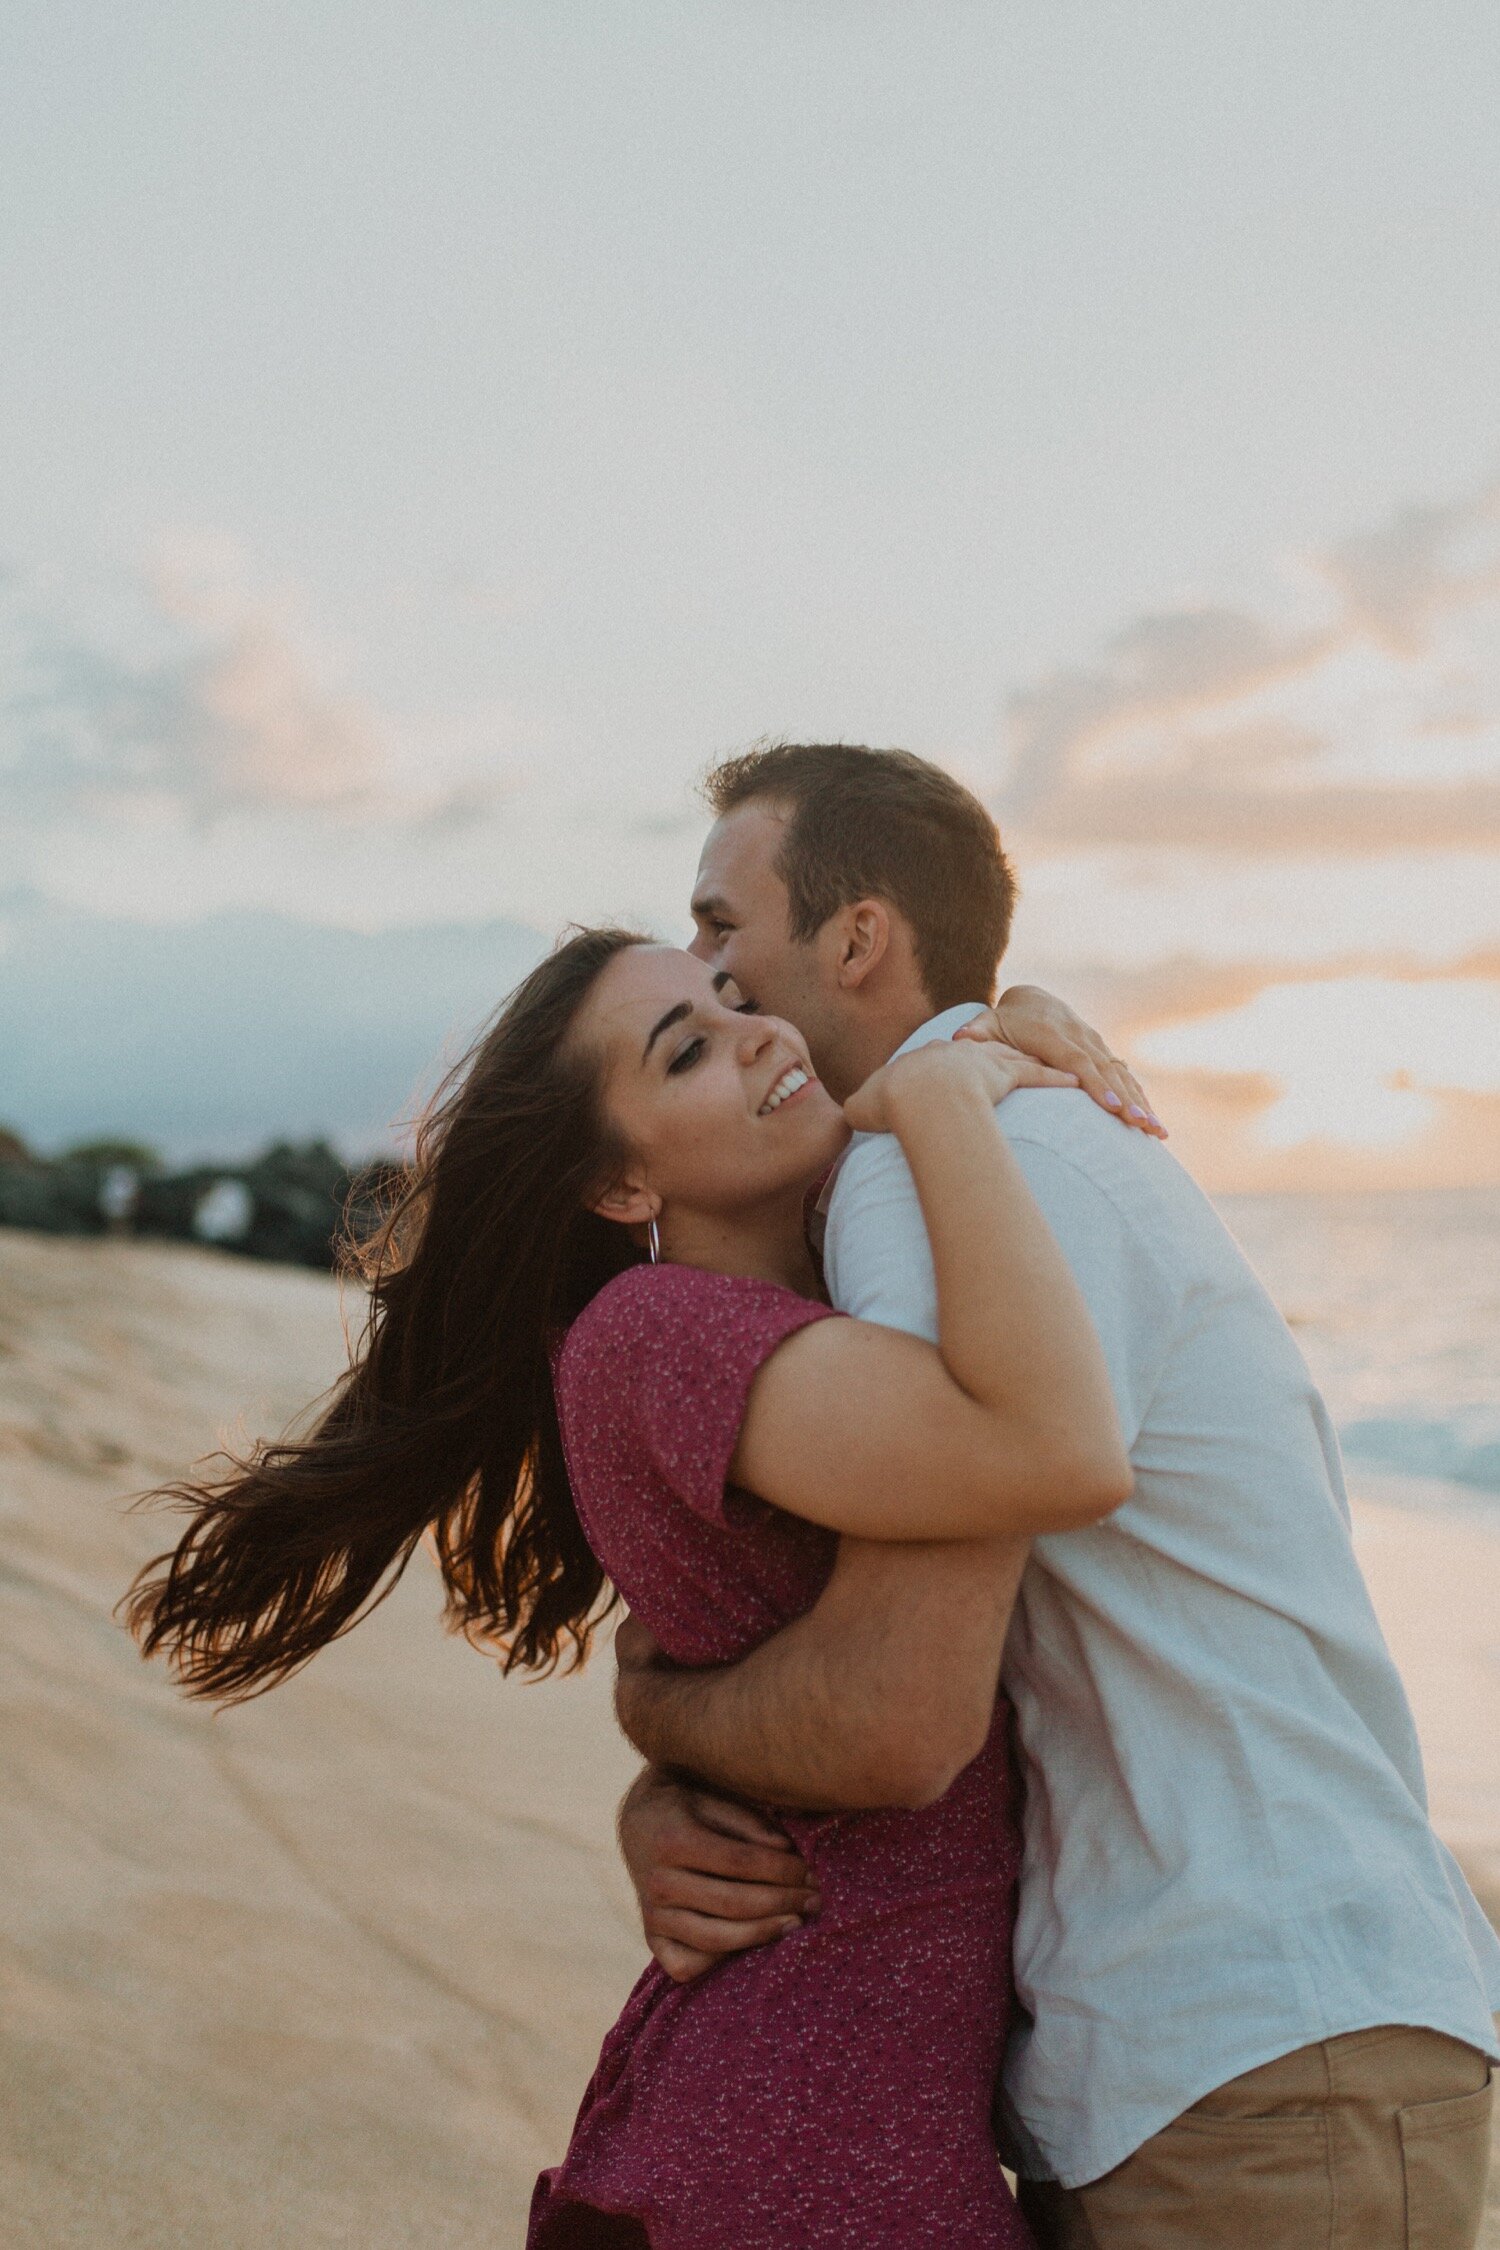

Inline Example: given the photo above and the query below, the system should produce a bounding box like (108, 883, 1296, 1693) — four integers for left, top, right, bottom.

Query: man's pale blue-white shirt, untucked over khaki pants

(825, 1008, 1500, 2187)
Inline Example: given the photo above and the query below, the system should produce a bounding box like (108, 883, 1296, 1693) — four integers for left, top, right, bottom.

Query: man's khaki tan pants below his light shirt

(1021, 2027, 1491, 2250)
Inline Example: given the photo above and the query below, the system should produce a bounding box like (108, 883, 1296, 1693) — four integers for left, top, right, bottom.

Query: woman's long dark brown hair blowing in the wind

(124, 929, 641, 1703)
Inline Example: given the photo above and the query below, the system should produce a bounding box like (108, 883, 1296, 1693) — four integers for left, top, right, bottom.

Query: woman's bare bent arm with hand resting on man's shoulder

(731, 1042, 1131, 1539)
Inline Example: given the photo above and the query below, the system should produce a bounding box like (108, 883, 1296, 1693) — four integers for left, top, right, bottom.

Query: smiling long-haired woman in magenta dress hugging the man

(130, 932, 1129, 2250)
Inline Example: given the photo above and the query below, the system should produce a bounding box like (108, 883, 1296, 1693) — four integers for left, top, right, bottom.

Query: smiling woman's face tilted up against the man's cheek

(576, 945, 848, 1231)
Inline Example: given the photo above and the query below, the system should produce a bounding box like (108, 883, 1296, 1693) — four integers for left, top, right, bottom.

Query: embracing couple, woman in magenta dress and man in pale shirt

(133, 745, 1500, 2250)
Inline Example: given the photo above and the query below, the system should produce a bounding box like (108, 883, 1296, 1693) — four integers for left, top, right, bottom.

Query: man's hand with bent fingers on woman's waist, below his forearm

(621, 1766, 819, 1985)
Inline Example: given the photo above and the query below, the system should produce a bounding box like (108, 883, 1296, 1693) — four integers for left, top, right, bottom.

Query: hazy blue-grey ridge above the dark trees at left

(0, 891, 546, 1161)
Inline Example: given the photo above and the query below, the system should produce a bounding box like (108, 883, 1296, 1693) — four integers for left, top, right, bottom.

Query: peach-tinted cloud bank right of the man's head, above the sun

(1001, 486, 1500, 855)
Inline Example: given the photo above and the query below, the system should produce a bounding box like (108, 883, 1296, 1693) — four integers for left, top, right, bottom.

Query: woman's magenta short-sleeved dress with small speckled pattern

(526, 1265, 1030, 2250)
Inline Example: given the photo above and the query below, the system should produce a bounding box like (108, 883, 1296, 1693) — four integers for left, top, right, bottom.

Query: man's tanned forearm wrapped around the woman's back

(618, 1539, 1025, 1811)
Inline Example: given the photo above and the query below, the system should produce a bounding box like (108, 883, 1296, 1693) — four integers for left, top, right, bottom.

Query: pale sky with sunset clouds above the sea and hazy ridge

(0, 0, 1500, 1186)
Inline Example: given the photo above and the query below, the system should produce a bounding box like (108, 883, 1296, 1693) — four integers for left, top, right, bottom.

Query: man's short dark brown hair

(704, 743, 1016, 1008)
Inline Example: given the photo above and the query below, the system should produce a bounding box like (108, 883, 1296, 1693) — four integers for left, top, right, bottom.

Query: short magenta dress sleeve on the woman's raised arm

(558, 1265, 839, 1523)
